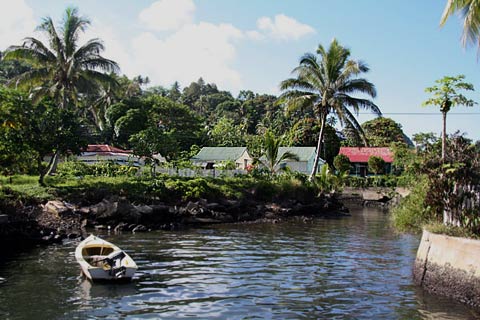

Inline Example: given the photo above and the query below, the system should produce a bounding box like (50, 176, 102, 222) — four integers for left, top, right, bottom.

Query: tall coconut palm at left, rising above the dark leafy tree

(4, 8, 119, 173)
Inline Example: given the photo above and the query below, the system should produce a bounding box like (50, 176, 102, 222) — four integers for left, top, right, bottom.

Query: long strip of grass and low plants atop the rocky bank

(0, 175, 315, 203)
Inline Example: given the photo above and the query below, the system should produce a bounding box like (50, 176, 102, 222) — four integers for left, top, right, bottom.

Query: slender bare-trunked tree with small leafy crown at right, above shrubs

(423, 75, 475, 159)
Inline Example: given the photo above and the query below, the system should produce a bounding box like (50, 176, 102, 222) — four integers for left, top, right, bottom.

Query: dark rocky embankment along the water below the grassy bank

(0, 196, 348, 243)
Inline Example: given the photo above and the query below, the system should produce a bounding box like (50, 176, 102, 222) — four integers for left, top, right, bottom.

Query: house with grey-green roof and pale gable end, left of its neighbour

(190, 147, 253, 170)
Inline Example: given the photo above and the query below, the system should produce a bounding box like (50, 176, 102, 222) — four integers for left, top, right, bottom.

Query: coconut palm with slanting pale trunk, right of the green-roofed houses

(280, 39, 382, 180)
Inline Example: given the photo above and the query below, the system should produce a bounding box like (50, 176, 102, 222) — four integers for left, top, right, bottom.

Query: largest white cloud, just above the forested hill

(132, 22, 244, 90)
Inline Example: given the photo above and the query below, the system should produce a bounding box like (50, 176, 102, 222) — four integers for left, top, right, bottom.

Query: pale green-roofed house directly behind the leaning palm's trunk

(270, 147, 325, 174)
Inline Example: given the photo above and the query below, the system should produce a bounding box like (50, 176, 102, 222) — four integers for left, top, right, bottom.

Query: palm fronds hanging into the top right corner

(440, 0, 480, 47)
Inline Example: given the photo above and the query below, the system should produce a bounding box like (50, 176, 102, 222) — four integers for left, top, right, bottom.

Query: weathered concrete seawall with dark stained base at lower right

(413, 230, 480, 307)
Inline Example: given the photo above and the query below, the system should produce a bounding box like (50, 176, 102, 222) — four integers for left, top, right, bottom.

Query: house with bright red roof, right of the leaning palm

(339, 147, 393, 177)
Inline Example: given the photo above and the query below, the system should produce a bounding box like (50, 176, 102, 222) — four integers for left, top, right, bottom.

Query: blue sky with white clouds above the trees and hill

(0, 0, 480, 140)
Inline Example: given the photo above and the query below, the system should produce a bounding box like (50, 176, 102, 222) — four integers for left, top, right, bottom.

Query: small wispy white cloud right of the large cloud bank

(257, 14, 315, 40)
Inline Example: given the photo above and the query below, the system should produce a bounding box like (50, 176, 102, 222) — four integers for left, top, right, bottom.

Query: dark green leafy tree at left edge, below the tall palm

(0, 86, 87, 185)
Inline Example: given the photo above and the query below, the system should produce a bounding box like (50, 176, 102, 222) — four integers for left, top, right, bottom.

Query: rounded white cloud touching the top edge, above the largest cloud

(139, 0, 195, 31)
